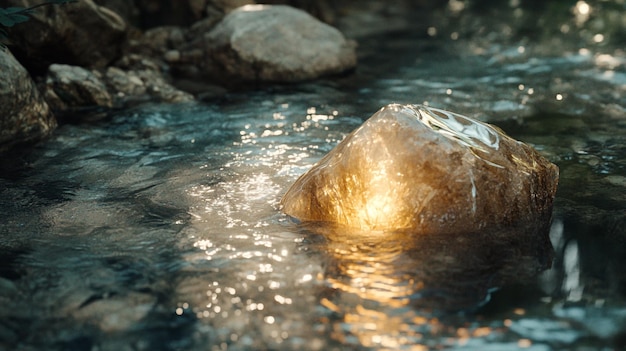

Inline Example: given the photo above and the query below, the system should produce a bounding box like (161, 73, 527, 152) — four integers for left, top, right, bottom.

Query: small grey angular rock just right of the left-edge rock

(44, 64, 113, 117)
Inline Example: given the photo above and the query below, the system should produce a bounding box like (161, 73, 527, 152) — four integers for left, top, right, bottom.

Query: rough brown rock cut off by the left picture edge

(0, 49, 57, 152)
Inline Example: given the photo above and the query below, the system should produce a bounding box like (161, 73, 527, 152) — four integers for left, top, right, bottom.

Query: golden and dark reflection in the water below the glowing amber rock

(302, 224, 552, 350)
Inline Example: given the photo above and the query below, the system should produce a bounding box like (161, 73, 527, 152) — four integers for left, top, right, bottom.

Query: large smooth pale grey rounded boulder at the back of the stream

(181, 5, 356, 82)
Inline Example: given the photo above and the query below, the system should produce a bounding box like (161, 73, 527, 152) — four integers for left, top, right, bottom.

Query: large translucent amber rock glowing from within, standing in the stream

(281, 104, 558, 234)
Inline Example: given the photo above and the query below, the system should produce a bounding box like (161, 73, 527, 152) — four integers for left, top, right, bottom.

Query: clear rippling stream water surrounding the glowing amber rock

(0, 28, 626, 350)
